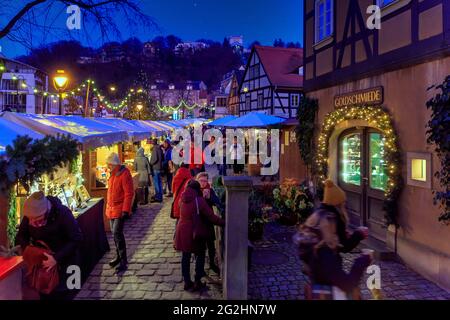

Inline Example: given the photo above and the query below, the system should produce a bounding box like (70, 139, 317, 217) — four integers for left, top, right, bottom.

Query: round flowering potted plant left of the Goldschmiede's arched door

(273, 179, 314, 225)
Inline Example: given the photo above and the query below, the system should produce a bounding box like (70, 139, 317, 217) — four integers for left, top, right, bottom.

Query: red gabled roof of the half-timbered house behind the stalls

(254, 46, 303, 88)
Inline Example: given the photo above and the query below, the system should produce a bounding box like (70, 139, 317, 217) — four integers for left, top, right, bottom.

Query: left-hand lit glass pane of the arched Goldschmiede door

(341, 134, 361, 186)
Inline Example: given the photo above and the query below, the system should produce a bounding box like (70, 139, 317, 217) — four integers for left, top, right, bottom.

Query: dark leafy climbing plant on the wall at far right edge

(427, 75, 450, 224)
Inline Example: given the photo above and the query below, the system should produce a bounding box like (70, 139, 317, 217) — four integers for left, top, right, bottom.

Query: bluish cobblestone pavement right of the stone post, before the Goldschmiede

(248, 223, 450, 300)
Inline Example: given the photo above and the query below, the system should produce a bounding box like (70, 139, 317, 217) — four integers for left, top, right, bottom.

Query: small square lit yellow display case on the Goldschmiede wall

(407, 152, 432, 189)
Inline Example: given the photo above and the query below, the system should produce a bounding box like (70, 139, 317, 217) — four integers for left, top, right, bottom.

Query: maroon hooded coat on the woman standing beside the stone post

(175, 187, 225, 253)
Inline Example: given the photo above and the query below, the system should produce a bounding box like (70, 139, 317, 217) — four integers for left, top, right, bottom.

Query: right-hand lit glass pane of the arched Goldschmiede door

(369, 133, 388, 191)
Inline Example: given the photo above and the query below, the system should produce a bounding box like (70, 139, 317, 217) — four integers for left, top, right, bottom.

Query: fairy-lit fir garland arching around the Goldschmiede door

(314, 106, 403, 227)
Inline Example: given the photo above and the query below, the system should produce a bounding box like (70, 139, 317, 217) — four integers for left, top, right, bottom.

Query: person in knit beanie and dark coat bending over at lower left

(16, 192, 83, 299)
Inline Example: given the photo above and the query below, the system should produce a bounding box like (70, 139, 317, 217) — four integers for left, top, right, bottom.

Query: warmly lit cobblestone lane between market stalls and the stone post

(76, 200, 222, 300)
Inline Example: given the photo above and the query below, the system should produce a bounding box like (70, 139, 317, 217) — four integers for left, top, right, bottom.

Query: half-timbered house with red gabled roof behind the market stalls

(239, 46, 303, 118)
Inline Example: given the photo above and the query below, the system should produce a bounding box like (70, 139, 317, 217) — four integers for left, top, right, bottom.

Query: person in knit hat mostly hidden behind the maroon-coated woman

(196, 172, 222, 274)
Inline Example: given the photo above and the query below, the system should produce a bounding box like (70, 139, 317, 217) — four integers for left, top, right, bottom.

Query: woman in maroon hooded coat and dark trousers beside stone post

(174, 181, 225, 291)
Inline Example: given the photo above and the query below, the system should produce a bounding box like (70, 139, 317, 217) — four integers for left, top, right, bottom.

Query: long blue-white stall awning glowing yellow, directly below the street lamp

(2, 112, 128, 148)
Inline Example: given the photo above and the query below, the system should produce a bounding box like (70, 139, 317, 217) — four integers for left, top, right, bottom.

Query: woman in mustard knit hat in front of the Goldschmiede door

(305, 180, 372, 298)
